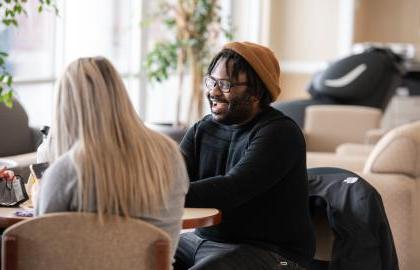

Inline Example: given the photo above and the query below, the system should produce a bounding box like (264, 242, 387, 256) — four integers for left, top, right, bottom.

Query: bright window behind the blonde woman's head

(0, 0, 231, 127)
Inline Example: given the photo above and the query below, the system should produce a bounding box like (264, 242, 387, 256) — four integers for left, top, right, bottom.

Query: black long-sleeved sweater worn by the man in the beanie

(181, 107, 315, 264)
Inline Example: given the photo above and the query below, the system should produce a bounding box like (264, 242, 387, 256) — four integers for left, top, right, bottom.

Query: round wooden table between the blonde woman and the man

(0, 207, 222, 229)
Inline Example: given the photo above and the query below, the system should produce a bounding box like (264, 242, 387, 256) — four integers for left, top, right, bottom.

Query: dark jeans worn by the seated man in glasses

(174, 232, 304, 270)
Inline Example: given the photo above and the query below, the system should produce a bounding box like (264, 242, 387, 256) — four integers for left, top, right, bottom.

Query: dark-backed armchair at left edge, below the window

(0, 100, 42, 178)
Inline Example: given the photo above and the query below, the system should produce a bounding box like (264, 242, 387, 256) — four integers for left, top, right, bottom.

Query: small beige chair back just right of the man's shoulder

(304, 105, 382, 152)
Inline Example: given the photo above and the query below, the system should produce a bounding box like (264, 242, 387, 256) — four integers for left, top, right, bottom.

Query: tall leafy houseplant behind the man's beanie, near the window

(145, 0, 232, 126)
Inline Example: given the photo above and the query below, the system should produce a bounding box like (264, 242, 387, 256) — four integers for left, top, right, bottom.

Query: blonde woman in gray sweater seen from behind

(36, 57, 188, 254)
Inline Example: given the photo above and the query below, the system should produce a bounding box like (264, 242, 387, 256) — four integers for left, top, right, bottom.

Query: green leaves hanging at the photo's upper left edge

(0, 0, 58, 107)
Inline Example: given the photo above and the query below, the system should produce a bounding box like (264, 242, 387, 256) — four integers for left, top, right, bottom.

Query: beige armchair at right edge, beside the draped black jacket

(364, 121, 420, 270)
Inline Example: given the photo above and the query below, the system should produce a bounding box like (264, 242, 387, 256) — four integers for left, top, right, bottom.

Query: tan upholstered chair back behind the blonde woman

(2, 213, 170, 270)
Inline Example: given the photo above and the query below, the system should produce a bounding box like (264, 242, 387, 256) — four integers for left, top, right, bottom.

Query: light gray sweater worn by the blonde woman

(35, 151, 188, 255)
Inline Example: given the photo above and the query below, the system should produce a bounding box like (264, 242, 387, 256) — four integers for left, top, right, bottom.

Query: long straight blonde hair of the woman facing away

(51, 57, 182, 216)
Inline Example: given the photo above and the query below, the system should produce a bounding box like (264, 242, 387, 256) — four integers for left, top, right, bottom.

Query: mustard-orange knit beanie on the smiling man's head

(223, 42, 281, 101)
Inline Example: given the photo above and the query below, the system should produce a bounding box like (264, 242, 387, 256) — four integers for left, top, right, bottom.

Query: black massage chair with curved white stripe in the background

(272, 45, 404, 127)
